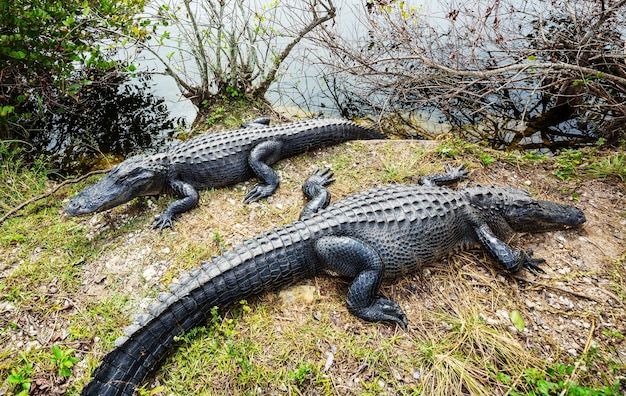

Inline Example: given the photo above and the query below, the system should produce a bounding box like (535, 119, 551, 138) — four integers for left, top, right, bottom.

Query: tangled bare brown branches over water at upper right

(318, 0, 626, 149)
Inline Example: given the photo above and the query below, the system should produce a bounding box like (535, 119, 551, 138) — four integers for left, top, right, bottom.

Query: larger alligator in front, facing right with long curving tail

(82, 167, 585, 396)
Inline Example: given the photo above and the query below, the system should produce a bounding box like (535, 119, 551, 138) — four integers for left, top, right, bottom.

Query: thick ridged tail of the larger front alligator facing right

(81, 222, 316, 396)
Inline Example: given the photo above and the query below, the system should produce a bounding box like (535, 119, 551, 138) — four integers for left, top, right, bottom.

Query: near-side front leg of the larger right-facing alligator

(474, 224, 546, 275)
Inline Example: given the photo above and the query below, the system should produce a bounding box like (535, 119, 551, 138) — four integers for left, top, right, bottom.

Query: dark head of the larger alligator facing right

(467, 187, 587, 232)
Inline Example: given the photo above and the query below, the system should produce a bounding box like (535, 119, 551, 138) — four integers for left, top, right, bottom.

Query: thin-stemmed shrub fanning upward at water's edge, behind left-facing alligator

(139, 0, 336, 106)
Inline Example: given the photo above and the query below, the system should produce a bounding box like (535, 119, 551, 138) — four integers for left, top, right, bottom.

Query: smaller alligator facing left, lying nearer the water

(65, 118, 386, 231)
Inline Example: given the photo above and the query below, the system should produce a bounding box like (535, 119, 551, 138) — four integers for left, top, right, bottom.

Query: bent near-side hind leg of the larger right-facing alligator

(315, 236, 408, 329)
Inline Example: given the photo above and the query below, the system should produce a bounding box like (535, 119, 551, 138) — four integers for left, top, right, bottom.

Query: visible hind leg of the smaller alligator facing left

(243, 140, 283, 203)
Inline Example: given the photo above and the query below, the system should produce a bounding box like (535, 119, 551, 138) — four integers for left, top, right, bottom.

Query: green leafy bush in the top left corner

(0, 0, 144, 139)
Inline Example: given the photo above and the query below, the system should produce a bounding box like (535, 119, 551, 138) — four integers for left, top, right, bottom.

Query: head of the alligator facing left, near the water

(65, 154, 167, 216)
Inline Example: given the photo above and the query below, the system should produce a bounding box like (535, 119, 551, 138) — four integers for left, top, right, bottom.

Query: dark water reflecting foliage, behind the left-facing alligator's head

(25, 75, 195, 174)
